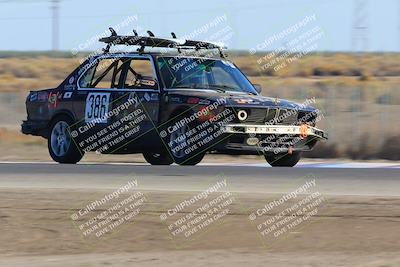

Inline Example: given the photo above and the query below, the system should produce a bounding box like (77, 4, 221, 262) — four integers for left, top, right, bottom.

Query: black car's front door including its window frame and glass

(113, 55, 161, 153)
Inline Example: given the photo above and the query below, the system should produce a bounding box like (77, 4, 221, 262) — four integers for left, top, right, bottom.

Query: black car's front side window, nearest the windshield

(124, 58, 157, 89)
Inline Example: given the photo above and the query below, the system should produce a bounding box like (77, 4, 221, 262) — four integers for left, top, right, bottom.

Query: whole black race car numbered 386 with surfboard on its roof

(22, 29, 327, 166)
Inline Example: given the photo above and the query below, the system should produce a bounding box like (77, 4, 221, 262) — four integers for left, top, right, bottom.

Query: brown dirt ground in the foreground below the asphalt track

(0, 188, 400, 267)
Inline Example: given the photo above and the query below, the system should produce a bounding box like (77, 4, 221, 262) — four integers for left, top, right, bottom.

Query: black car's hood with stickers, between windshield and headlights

(168, 89, 315, 111)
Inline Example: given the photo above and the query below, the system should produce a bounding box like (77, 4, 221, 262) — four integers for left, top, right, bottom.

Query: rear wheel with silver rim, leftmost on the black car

(47, 116, 83, 164)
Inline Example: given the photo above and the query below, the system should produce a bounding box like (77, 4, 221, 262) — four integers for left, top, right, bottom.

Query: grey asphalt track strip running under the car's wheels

(0, 163, 400, 196)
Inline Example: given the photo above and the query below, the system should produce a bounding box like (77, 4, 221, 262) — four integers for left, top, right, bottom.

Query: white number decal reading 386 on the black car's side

(85, 93, 110, 123)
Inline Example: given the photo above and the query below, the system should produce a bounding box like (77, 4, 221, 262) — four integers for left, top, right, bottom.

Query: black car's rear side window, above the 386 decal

(79, 59, 122, 89)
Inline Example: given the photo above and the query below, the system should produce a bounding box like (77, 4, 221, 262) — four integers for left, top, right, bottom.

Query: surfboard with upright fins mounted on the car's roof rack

(99, 27, 226, 58)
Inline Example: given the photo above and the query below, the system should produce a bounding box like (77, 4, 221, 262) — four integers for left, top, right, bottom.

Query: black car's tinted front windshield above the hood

(157, 57, 257, 94)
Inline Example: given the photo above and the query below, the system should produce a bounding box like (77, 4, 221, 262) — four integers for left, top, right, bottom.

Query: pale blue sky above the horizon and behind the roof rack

(0, 0, 400, 51)
